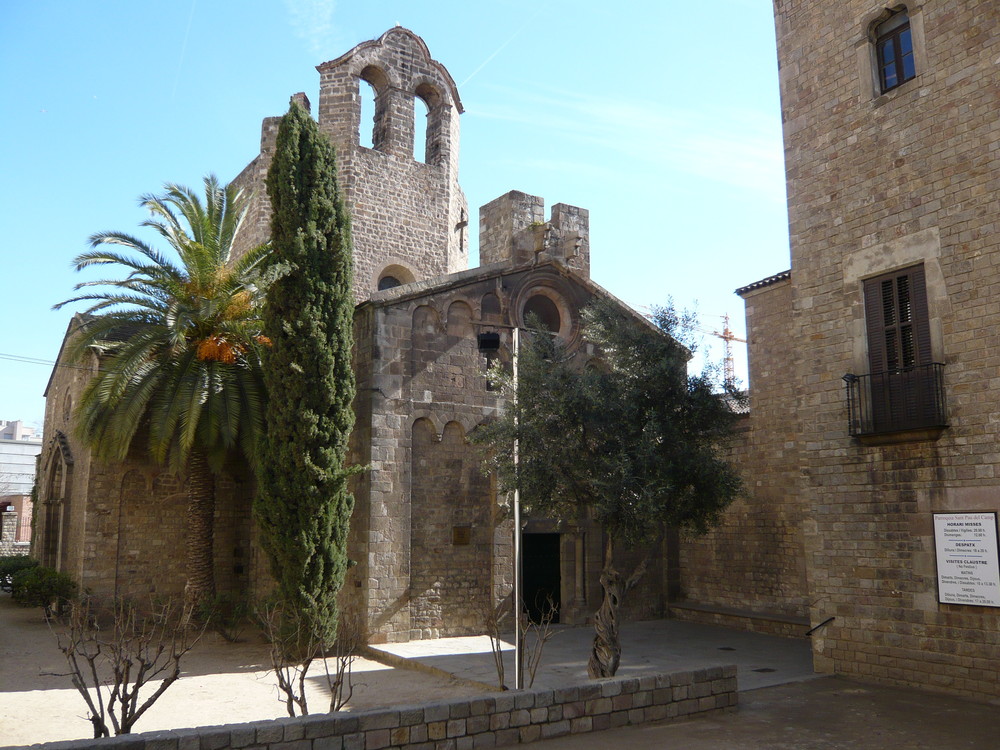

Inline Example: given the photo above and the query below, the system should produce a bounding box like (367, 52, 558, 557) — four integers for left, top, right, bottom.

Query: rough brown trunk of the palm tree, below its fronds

(184, 450, 215, 612)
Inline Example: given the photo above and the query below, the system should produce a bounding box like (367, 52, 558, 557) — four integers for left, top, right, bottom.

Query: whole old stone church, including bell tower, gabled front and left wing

(36, 27, 666, 642)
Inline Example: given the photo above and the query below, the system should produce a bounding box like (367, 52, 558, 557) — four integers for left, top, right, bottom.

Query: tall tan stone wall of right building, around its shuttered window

(775, 0, 1000, 698)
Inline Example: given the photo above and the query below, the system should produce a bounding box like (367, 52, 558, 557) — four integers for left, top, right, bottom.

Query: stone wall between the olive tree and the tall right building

(670, 273, 808, 635)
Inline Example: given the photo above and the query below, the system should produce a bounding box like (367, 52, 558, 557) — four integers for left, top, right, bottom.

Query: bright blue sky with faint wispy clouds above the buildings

(0, 0, 789, 424)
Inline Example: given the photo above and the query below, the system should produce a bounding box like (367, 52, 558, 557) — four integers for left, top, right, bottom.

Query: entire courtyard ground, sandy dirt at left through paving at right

(0, 595, 1000, 750)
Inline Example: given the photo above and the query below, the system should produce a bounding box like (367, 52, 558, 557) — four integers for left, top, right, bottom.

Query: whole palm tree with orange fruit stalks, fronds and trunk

(56, 175, 268, 606)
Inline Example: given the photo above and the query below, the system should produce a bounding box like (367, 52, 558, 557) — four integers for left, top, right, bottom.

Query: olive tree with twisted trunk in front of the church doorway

(475, 300, 741, 677)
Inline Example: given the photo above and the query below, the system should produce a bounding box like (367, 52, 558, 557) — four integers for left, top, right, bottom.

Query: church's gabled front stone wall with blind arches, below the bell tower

(352, 261, 652, 642)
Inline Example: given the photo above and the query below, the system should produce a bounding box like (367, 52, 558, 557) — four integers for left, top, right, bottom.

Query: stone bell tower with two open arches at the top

(317, 26, 469, 302)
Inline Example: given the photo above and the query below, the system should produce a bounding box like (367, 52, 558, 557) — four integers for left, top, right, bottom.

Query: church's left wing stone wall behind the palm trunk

(38, 318, 258, 598)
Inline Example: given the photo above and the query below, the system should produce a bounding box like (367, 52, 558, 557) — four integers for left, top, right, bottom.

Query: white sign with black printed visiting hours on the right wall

(934, 513, 1000, 607)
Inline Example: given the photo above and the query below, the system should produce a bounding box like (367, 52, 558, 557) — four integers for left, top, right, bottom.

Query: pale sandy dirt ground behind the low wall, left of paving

(0, 594, 492, 746)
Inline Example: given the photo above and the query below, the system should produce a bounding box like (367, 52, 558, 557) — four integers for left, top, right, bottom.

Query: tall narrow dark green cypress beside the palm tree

(255, 101, 355, 647)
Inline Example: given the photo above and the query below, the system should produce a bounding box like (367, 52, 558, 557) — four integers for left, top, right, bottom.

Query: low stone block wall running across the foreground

(32, 666, 737, 750)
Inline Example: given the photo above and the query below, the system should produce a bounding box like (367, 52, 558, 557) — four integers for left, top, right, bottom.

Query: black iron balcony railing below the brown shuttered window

(844, 362, 948, 437)
